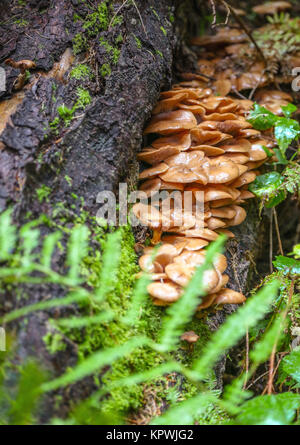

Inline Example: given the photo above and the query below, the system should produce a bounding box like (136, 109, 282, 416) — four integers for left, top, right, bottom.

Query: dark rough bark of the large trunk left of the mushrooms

(0, 0, 278, 419)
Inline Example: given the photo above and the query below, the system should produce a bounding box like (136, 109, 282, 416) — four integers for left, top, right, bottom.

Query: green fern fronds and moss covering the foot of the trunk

(0, 205, 300, 424)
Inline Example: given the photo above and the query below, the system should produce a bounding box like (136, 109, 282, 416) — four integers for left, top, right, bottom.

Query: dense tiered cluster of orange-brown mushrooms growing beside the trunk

(133, 24, 291, 310)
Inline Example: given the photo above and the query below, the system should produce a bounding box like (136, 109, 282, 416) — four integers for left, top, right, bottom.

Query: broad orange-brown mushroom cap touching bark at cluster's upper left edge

(144, 110, 197, 134)
